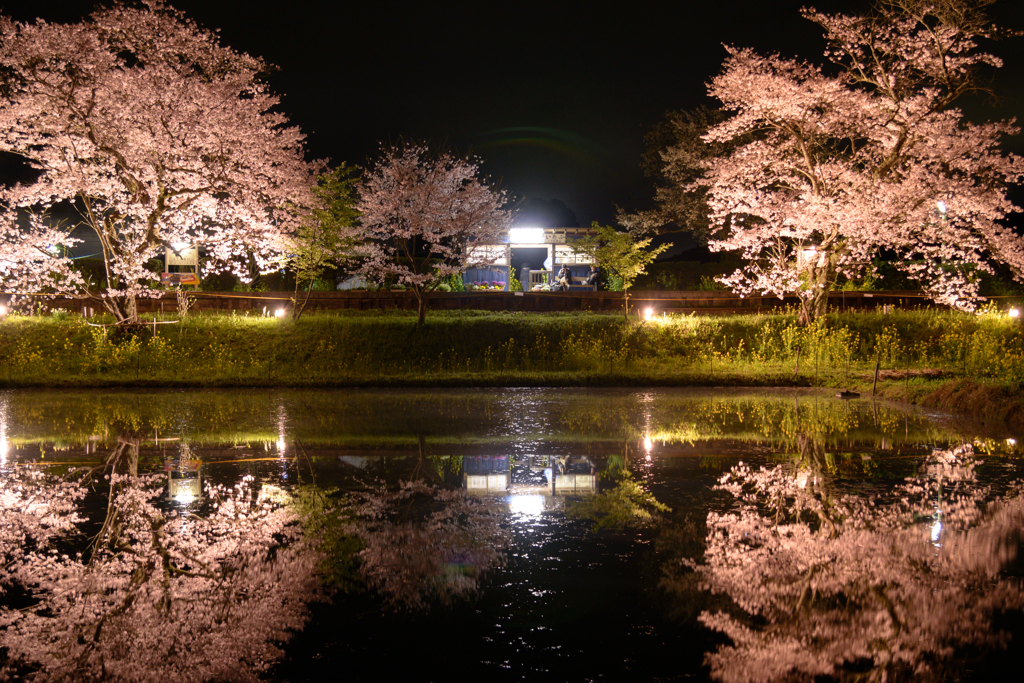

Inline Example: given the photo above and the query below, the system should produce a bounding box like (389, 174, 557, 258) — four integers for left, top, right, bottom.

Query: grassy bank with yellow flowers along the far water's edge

(0, 309, 1024, 422)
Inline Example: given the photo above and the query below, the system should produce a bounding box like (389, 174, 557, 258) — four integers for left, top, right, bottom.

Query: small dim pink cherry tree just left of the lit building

(357, 144, 511, 325)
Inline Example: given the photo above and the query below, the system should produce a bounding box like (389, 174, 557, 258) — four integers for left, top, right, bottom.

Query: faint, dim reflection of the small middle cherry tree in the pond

(346, 480, 508, 608)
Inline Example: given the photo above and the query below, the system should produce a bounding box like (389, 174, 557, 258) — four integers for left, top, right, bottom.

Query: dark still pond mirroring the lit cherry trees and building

(0, 389, 1024, 682)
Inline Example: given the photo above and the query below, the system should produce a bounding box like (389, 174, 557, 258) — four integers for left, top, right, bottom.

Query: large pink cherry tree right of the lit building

(698, 0, 1024, 324)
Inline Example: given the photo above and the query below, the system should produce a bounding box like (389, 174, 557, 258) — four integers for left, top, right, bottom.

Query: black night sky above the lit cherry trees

(0, 0, 1024, 225)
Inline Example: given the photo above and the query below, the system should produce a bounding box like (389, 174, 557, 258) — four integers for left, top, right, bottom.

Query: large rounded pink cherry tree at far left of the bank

(0, 0, 313, 321)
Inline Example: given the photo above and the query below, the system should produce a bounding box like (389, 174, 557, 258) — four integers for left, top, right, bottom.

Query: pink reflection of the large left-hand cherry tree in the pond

(0, 438, 317, 681)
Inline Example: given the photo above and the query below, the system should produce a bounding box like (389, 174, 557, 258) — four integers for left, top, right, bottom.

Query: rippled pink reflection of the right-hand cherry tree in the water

(669, 446, 1024, 682)
